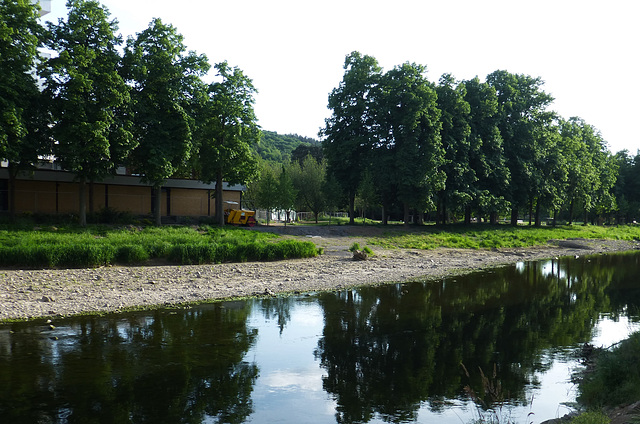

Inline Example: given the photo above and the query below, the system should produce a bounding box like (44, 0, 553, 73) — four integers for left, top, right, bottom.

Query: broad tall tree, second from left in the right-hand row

(374, 63, 445, 224)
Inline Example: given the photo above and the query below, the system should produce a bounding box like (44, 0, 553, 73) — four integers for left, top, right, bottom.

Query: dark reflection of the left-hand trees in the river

(0, 302, 258, 423)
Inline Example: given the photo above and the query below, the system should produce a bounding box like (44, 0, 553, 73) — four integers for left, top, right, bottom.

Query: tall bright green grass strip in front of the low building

(0, 226, 317, 268)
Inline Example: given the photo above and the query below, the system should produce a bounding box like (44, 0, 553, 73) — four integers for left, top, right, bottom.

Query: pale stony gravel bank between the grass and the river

(0, 226, 640, 321)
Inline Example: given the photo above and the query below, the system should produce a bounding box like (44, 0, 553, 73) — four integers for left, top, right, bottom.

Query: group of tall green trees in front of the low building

(0, 0, 260, 225)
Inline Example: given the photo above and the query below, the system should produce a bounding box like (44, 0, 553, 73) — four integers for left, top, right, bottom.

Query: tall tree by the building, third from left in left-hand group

(124, 18, 210, 225)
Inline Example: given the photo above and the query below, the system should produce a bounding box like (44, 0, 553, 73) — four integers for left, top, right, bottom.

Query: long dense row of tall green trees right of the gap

(321, 52, 640, 225)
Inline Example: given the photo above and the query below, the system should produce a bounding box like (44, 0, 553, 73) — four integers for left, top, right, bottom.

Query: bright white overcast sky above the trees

(45, 0, 640, 154)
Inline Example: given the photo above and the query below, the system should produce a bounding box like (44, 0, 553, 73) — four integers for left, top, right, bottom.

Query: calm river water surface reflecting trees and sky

(0, 250, 640, 424)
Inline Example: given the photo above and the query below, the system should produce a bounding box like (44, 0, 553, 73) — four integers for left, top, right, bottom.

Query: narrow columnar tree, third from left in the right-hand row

(436, 74, 478, 223)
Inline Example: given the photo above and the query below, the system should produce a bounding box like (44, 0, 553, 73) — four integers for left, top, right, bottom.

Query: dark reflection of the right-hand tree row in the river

(317, 255, 640, 423)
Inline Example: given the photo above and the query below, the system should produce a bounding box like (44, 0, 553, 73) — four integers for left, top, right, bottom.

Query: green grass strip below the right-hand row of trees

(369, 224, 640, 249)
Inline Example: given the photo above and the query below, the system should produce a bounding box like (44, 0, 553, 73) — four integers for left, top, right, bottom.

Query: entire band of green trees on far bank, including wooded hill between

(0, 0, 640, 229)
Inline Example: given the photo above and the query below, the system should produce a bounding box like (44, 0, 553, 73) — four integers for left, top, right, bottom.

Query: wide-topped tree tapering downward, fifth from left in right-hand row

(487, 71, 553, 225)
